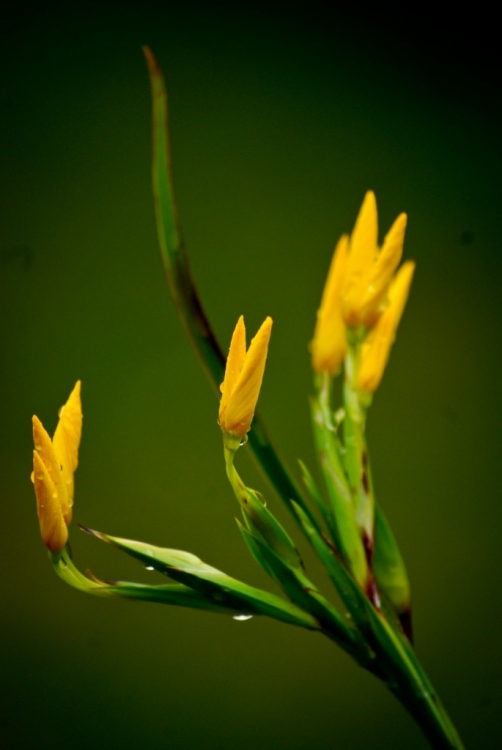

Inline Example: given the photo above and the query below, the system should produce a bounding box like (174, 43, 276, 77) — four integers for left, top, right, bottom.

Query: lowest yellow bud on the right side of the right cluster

(358, 260, 415, 393)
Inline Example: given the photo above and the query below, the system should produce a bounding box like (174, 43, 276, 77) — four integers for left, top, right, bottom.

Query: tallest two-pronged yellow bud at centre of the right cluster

(342, 191, 407, 328)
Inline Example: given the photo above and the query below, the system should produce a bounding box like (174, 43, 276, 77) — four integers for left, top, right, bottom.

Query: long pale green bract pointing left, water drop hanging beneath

(80, 529, 320, 630)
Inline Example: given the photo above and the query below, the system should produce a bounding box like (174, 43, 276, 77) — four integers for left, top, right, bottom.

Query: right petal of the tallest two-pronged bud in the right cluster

(359, 214, 407, 328)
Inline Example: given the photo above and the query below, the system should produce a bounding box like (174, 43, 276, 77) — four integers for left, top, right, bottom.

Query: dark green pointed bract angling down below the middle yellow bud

(239, 525, 356, 652)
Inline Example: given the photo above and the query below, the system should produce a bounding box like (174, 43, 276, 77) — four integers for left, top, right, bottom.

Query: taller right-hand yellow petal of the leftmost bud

(52, 380, 82, 508)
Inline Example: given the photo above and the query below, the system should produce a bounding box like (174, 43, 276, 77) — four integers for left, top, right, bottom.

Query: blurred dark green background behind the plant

(0, 0, 502, 750)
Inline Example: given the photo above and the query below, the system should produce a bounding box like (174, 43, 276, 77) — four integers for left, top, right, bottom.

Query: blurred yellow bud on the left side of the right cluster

(310, 235, 349, 375)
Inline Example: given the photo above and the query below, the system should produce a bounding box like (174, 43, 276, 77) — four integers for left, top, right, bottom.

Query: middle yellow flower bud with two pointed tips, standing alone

(219, 315, 272, 437)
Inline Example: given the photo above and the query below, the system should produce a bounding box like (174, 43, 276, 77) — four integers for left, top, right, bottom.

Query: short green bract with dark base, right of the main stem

(373, 503, 411, 640)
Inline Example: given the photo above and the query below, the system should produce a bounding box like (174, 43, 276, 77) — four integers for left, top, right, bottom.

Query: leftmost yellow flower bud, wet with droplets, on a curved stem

(31, 380, 82, 552)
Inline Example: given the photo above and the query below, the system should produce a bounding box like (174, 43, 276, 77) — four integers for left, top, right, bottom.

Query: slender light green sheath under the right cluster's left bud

(310, 398, 368, 587)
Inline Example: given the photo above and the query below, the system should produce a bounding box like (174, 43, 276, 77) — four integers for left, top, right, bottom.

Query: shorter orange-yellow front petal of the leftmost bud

(33, 450, 68, 553)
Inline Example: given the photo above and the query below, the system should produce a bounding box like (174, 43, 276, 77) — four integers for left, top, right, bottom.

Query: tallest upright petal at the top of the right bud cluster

(342, 190, 378, 326)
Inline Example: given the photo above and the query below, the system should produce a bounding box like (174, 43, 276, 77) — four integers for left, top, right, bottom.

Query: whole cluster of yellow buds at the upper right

(311, 191, 415, 393)
